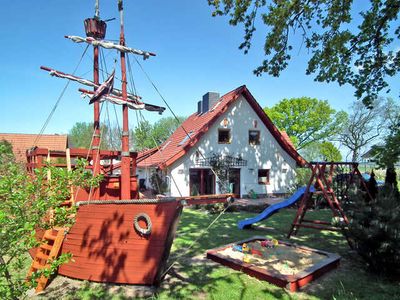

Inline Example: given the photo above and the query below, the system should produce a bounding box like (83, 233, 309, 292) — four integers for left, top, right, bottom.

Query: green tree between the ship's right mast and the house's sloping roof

(132, 117, 185, 150)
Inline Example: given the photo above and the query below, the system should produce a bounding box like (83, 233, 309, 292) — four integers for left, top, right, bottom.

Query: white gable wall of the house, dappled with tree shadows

(168, 96, 296, 196)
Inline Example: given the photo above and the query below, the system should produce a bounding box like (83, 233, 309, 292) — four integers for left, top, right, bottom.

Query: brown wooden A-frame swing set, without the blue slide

(288, 162, 372, 238)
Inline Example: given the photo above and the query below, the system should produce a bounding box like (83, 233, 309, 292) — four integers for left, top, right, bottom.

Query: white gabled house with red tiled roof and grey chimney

(138, 86, 306, 196)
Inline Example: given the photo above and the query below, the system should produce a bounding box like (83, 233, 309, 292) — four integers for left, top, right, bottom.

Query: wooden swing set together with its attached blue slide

(238, 162, 372, 238)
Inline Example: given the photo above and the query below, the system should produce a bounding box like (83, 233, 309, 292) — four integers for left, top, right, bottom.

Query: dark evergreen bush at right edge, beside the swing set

(345, 186, 400, 275)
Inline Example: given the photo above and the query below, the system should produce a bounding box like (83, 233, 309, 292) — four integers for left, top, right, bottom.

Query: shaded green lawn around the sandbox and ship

(36, 209, 400, 300)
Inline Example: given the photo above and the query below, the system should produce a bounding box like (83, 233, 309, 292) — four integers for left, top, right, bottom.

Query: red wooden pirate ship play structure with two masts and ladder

(27, 0, 231, 290)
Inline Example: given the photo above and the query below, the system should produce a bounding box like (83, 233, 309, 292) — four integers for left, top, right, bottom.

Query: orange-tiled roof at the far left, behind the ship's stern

(0, 133, 68, 163)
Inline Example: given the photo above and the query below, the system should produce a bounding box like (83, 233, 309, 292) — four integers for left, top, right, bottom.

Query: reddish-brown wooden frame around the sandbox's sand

(207, 236, 340, 292)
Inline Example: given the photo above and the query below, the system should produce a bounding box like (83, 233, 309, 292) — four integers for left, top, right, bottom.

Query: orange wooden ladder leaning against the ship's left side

(27, 228, 66, 293)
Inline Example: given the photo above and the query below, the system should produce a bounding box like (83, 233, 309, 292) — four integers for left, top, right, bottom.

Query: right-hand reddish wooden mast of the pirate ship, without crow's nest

(118, 0, 131, 199)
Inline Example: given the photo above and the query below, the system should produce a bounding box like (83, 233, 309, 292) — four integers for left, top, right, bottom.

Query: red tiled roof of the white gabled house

(138, 85, 307, 168)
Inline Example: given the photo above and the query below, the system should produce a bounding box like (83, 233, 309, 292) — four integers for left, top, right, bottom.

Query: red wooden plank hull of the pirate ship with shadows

(59, 200, 182, 285)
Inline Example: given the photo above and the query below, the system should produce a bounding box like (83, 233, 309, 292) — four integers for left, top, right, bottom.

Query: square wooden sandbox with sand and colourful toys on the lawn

(207, 236, 340, 292)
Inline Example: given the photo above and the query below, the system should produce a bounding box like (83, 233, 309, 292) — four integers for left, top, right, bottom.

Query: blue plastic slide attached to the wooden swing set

(238, 186, 315, 229)
